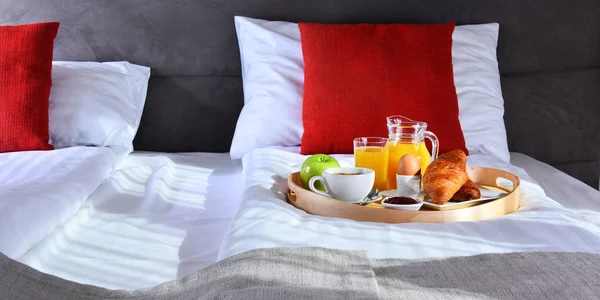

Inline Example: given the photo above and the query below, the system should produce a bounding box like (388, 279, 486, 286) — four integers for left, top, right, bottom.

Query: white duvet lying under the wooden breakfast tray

(219, 148, 600, 259)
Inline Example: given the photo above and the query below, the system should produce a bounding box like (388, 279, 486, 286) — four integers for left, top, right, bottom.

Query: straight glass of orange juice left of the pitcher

(354, 137, 396, 191)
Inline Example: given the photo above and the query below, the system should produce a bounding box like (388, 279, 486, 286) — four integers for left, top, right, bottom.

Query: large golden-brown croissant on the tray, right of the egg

(423, 149, 469, 205)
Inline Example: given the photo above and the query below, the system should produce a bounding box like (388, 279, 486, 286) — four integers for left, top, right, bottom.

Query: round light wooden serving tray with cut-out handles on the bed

(287, 167, 521, 223)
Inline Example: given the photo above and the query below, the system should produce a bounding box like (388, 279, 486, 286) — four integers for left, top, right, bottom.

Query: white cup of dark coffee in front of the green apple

(308, 167, 375, 203)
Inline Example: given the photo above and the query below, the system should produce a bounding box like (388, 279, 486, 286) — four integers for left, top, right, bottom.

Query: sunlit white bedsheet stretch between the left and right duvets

(20, 153, 242, 289)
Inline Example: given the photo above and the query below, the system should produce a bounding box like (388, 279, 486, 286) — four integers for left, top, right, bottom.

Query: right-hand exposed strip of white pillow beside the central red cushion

(452, 23, 510, 163)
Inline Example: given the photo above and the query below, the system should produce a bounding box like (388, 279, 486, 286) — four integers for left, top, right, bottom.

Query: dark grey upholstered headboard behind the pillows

(0, 0, 600, 186)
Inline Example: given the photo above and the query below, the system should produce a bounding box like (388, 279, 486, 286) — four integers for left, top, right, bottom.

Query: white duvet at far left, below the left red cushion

(0, 147, 122, 259)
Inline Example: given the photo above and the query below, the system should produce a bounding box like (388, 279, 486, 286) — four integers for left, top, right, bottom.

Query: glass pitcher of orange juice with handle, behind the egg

(386, 115, 439, 190)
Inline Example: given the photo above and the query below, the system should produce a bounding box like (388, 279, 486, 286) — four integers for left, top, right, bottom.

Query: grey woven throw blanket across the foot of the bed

(0, 248, 600, 300)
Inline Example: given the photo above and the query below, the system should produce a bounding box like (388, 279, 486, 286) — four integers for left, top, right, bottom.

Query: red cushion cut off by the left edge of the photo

(0, 23, 59, 152)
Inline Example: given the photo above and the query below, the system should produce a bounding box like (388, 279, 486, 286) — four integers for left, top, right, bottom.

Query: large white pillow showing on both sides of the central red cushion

(230, 16, 510, 162)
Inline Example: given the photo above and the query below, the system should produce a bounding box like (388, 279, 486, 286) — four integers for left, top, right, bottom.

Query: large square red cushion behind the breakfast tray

(299, 23, 467, 154)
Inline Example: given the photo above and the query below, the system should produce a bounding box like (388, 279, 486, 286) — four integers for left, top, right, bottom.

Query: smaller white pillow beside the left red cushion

(49, 61, 150, 149)
